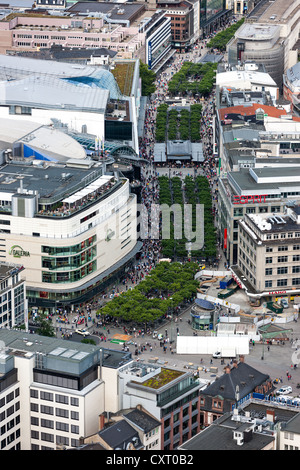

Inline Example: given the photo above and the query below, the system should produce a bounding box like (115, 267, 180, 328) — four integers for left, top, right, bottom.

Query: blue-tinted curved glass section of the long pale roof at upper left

(64, 68, 122, 99)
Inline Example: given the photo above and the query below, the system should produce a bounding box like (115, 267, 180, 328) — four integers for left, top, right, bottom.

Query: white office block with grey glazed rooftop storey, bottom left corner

(0, 329, 131, 450)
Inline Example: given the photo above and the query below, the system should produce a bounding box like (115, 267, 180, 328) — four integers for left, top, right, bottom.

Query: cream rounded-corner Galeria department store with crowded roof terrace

(0, 162, 139, 308)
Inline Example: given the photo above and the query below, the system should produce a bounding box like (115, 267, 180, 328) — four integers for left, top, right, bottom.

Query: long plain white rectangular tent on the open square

(176, 336, 249, 357)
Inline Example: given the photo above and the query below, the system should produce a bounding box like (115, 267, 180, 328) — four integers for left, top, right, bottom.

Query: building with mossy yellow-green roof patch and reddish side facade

(119, 363, 204, 450)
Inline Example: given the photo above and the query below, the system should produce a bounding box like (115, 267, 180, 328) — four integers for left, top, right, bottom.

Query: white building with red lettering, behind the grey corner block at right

(217, 166, 300, 265)
